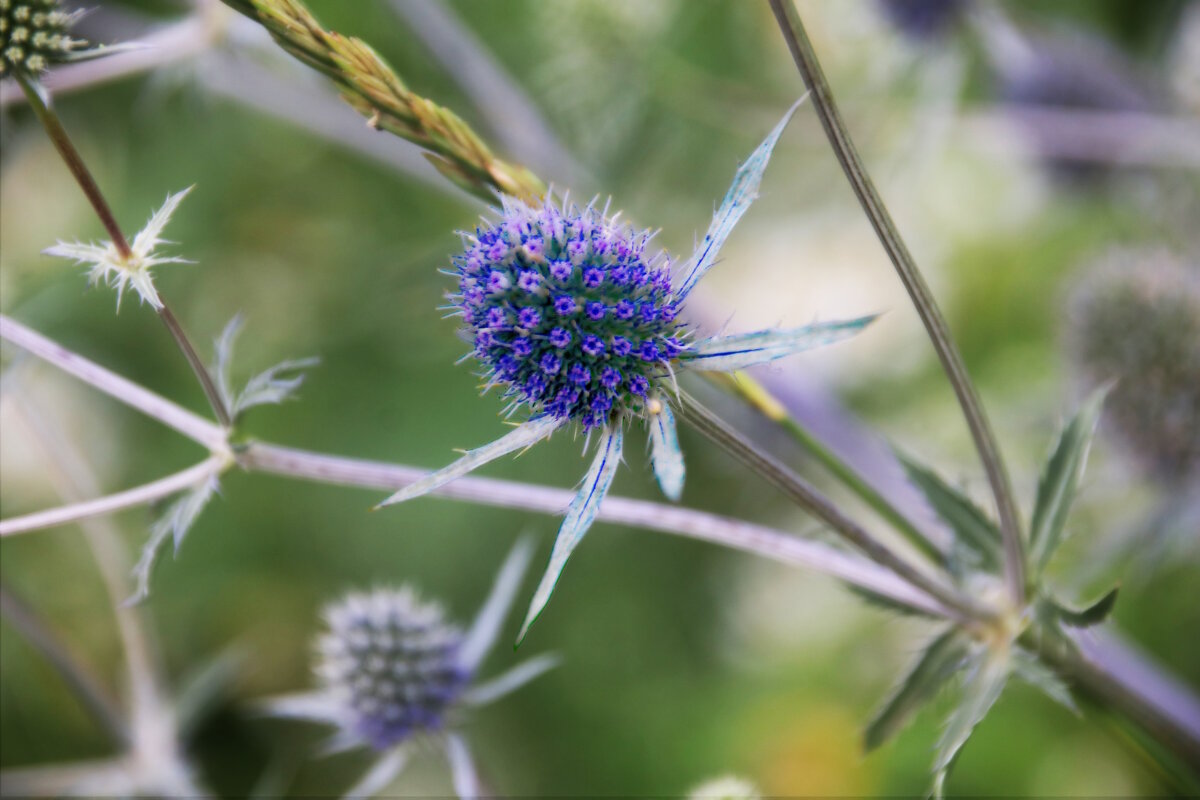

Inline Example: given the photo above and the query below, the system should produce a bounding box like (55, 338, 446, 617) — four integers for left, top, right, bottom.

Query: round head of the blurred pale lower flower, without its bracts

(317, 588, 470, 750)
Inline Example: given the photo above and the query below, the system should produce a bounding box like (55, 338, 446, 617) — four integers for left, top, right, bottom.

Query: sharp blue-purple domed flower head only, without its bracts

(450, 201, 685, 428)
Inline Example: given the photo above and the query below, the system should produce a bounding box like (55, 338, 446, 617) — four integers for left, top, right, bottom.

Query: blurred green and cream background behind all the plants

(0, 0, 1200, 796)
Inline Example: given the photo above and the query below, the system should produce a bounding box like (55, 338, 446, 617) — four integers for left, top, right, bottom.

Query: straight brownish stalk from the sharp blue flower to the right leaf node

(680, 392, 996, 626)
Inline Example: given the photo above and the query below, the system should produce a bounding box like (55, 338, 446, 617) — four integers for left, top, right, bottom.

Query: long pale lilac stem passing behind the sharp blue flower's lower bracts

(238, 443, 956, 619)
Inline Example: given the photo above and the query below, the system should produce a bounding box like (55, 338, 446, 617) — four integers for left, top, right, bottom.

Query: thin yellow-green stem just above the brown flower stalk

(708, 372, 946, 565)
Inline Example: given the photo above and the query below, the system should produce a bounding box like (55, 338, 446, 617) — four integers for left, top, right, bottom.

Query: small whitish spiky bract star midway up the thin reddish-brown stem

(45, 189, 193, 311)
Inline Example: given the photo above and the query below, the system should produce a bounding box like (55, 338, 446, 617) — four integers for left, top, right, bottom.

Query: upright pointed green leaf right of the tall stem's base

(1030, 386, 1111, 573)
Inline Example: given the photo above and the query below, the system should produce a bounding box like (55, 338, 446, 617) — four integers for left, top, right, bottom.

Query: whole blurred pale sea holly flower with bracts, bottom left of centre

(266, 541, 558, 798)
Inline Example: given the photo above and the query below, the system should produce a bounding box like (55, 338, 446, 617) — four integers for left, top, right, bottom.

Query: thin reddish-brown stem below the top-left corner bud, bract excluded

(14, 72, 233, 431)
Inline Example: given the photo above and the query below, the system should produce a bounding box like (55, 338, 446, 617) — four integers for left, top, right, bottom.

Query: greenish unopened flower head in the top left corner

(0, 0, 85, 77)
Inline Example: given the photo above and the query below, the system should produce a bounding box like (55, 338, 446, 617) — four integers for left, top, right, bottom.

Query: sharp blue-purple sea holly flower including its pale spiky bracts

(380, 103, 874, 637)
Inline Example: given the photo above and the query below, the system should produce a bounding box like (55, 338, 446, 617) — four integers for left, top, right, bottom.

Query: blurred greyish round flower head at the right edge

(1068, 249, 1200, 481)
